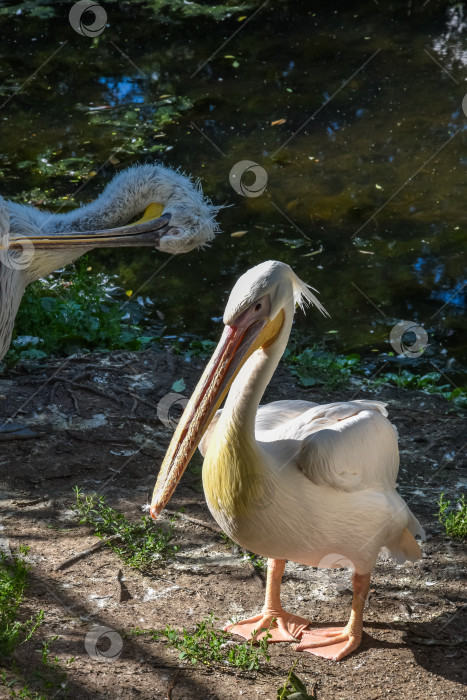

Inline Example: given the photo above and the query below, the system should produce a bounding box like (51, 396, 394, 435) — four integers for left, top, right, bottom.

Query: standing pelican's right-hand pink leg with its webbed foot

(295, 574, 370, 661)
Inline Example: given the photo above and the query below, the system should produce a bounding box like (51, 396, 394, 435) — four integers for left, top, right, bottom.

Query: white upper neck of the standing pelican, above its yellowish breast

(219, 298, 294, 441)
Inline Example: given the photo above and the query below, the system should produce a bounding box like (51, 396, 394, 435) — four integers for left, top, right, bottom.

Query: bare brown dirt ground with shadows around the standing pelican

(0, 350, 467, 700)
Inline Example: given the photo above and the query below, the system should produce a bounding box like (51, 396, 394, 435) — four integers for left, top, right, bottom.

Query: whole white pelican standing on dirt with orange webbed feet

(151, 261, 424, 660)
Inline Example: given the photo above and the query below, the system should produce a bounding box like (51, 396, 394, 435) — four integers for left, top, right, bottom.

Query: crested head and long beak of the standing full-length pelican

(151, 260, 327, 518)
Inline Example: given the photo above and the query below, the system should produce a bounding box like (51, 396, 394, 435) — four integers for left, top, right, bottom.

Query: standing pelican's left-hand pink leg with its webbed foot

(224, 559, 310, 642)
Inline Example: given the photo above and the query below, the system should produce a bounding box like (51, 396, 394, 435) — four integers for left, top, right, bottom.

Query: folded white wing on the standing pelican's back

(258, 401, 399, 491)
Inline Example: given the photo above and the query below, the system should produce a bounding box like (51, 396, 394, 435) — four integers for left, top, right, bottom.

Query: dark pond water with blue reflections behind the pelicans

(0, 2, 467, 372)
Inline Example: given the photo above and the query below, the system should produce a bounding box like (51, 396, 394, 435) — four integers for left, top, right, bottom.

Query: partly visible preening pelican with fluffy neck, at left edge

(0, 165, 216, 360)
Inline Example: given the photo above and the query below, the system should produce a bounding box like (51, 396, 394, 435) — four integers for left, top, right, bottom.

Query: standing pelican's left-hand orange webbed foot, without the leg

(224, 610, 311, 642)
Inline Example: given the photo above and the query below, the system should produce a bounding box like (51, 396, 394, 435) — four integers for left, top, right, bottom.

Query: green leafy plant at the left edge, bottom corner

(0, 546, 44, 658)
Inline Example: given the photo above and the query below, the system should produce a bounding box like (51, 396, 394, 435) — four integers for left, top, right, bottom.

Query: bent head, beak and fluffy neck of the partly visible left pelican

(0, 165, 219, 257)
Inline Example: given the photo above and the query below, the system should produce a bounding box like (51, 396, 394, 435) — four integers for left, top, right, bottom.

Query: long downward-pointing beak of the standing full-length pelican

(150, 310, 284, 518)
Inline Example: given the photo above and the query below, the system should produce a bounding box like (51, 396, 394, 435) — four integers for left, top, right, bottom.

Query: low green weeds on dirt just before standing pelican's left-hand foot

(146, 613, 271, 671)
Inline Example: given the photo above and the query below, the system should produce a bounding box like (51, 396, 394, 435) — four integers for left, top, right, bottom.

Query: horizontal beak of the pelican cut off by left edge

(4, 204, 176, 250)
